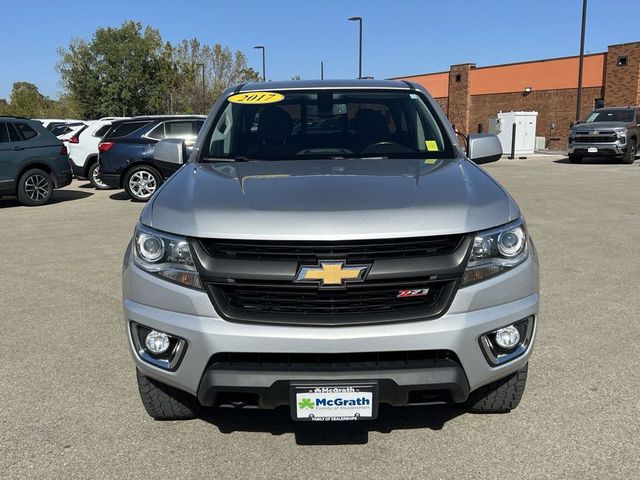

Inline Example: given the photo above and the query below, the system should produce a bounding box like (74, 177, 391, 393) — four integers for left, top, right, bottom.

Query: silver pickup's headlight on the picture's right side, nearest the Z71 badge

(462, 218, 529, 286)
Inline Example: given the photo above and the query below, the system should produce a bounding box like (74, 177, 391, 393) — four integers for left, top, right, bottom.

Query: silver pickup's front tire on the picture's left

(136, 369, 202, 420)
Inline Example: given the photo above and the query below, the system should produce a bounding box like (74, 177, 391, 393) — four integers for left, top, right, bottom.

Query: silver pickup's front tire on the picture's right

(467, 363, 529, 413)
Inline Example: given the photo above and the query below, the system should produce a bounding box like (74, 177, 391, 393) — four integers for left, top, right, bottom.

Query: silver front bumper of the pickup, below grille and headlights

(123, 246, 539, 407)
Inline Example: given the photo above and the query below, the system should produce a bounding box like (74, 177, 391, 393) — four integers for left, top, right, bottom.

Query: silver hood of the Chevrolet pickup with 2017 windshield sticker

(141, 159, 520, 240)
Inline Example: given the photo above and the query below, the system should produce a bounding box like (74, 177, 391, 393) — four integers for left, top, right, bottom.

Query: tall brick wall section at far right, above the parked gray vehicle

(604, 42, 640, 107)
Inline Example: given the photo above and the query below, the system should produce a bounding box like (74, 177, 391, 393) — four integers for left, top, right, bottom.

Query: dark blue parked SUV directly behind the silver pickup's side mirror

(98, 115, 206, 202)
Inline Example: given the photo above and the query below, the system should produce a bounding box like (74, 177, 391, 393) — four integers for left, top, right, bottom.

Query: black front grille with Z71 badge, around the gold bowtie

(191, 234, 474, 326)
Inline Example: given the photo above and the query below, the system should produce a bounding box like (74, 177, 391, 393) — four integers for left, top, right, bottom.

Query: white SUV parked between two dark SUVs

(66, 117, 125, 190)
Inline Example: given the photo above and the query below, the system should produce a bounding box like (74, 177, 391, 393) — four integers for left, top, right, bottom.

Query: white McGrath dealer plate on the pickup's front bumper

(291, 383, 378, 422)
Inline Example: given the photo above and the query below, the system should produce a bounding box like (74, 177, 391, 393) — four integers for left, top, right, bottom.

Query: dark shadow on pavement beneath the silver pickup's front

(200, 405, 465, 445)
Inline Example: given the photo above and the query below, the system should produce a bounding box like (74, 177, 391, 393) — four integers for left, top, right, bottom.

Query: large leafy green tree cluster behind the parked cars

(57, 21, 259, 118)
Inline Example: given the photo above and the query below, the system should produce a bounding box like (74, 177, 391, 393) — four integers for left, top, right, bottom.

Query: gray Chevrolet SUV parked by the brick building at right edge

(569, 107, 640, 164)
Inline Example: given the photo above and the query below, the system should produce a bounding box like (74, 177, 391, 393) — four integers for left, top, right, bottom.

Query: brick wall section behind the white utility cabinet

(469, 88, 603, 149)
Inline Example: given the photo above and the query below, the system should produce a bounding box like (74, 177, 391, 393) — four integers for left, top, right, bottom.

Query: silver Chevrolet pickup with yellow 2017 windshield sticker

(123, 80, 539, 421)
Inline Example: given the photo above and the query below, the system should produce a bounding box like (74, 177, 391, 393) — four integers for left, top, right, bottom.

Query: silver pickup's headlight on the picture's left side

(133, 224, 202, 289)
